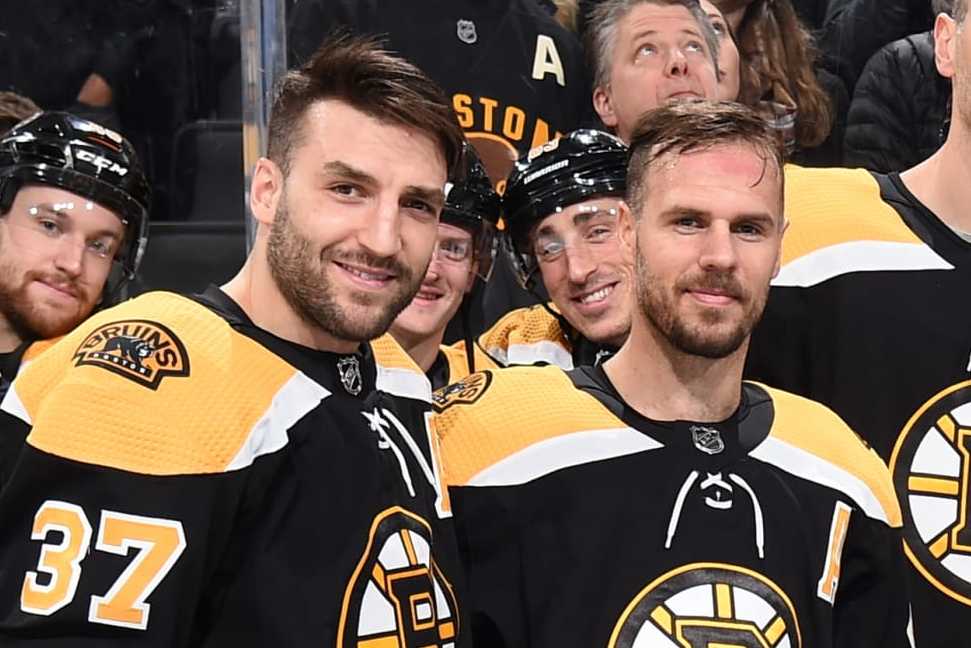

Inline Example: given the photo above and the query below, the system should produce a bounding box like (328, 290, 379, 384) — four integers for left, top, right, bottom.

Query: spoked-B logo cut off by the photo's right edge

(890, 381, 971, 605)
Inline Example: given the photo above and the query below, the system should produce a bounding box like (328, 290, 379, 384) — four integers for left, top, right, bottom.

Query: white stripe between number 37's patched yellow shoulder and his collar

(226, 372, 330, 471)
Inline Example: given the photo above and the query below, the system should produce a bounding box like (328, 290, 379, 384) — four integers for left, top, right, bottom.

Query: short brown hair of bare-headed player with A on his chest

(627, 100, 785, 217)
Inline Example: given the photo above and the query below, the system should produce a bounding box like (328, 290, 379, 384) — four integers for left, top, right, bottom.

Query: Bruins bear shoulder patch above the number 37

(74, 320, 189, 389)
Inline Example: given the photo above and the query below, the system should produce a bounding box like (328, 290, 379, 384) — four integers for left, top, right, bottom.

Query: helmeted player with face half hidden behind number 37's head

(391, 147, 499, 389)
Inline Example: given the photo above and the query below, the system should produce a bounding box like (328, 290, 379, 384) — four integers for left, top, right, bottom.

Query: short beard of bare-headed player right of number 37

(634, 248, 768, 360)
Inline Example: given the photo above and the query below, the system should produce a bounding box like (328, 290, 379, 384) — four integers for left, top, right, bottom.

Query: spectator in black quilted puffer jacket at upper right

(843, 0, 952, 173)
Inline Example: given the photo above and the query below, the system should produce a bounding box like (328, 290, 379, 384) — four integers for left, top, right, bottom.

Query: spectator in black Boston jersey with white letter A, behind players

(287, 0, 594, 341)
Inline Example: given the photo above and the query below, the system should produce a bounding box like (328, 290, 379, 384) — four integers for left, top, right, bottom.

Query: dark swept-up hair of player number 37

(267, 33, 464, 174)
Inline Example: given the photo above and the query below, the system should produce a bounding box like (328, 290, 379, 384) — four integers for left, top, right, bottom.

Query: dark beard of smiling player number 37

(267, 201, 425, 342)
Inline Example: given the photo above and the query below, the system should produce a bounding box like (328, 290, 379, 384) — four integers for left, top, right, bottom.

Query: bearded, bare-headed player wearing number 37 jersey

(0, 37, 462, 648)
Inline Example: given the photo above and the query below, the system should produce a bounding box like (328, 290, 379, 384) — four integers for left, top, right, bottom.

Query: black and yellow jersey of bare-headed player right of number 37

(435, 367, 909, 648)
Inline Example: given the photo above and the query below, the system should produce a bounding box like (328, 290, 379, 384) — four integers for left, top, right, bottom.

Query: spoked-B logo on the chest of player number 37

(337, 506, 459, 648)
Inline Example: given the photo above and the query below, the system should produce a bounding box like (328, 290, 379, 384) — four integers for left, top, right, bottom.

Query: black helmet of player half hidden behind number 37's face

(441, 145, 501, 280)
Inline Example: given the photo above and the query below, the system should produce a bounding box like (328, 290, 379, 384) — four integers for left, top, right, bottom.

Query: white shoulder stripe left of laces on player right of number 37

(468, 427, 663, 486)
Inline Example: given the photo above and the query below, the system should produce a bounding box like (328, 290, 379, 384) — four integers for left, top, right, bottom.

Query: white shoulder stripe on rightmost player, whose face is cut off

(772, 241, 954, 288)
